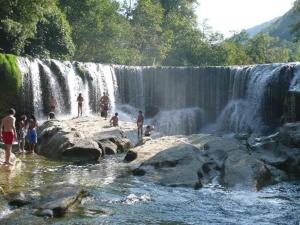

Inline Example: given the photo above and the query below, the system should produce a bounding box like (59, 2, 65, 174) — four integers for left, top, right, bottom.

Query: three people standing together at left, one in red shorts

(0, 108, 37, 165)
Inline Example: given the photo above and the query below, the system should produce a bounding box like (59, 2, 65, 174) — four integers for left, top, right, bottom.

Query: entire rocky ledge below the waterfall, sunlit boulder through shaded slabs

(33, 117, 300, 190)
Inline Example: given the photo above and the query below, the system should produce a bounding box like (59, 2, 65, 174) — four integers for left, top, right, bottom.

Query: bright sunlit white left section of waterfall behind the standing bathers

(18, 57, 117, 118)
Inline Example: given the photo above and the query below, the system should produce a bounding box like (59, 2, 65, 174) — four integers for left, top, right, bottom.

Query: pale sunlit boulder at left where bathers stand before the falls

(37, 119, 132, 162)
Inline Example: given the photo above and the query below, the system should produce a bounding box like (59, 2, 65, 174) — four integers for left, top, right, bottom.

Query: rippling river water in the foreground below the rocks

(0, 156, 300, 225)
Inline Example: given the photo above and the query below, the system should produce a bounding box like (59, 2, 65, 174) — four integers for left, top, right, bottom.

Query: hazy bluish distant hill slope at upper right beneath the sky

(247, 4, 300, 41)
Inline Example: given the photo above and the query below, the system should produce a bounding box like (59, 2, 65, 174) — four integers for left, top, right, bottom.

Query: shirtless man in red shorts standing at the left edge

(0, 109, 17, 165)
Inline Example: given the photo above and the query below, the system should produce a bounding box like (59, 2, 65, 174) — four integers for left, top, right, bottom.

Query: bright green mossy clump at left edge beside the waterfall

(0, 54, 22, 117)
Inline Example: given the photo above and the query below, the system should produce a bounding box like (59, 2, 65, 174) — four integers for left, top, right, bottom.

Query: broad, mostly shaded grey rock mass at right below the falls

(125, 134, 300, 190)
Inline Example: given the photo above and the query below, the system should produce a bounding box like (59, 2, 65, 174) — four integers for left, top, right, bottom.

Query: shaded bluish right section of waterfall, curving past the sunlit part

(116, 64, 298, 134)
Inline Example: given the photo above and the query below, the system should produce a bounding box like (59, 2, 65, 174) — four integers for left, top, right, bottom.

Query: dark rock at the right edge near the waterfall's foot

(279, 122, 300, 148)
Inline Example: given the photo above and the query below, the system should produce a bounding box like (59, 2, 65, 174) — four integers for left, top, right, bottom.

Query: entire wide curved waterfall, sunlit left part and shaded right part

(18, 57, 300, 134)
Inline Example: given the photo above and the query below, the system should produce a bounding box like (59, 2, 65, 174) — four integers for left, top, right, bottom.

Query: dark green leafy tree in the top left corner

(0, 0, 74, 58)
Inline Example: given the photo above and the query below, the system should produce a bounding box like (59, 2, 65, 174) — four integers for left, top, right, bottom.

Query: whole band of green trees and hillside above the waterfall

(0, 0, 300, 66)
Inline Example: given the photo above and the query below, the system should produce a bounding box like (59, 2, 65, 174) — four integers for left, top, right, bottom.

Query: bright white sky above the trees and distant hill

(197, 0, 295, 37)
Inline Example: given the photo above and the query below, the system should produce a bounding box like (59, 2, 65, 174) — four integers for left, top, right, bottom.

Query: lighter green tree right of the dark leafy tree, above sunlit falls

(60, 0, 136, 64)
